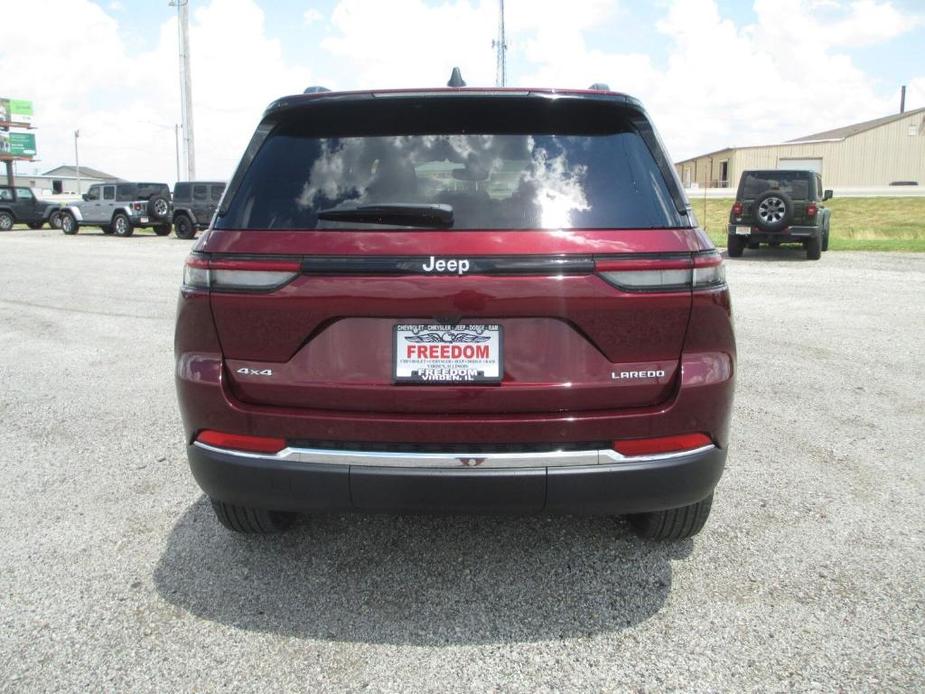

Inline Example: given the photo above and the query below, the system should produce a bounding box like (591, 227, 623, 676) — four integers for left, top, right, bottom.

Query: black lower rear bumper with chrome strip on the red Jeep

(187, 444, 726, 514)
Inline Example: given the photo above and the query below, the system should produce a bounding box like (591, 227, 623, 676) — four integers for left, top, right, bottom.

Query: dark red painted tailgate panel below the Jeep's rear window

(204, 230, 703, 414)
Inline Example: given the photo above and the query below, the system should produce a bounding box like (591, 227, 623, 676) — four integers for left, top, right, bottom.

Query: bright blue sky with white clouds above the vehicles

(0, 0, 925, 181)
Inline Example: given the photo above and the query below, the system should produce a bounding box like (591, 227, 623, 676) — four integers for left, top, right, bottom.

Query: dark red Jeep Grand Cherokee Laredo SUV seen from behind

(176, 89, 735, 539)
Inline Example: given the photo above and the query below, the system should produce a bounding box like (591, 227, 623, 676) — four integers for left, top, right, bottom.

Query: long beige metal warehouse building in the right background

(675, 108, 925, 188)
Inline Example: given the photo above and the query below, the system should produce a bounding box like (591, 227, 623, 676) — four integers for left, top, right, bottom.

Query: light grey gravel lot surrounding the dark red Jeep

(0, 230, 925, 691)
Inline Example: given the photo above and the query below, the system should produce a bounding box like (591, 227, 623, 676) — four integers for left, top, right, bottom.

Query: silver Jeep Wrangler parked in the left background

(61, 183, 172, 236)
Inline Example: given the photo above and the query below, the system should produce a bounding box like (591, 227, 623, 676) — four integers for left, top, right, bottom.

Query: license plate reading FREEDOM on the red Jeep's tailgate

(392, 323, 502, 383)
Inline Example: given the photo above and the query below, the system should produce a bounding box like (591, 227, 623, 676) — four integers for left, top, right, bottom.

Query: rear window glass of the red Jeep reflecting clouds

(216, 100, 689, 230)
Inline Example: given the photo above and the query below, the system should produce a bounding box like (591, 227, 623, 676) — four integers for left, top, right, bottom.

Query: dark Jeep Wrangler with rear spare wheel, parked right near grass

(727, 169, 832, 260)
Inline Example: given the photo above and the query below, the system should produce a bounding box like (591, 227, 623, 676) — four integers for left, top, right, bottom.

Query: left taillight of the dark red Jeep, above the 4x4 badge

(183, 255, 300, 292)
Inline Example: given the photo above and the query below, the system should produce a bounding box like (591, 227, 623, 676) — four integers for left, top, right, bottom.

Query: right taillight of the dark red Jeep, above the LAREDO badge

(594, 251, 726, 292)
